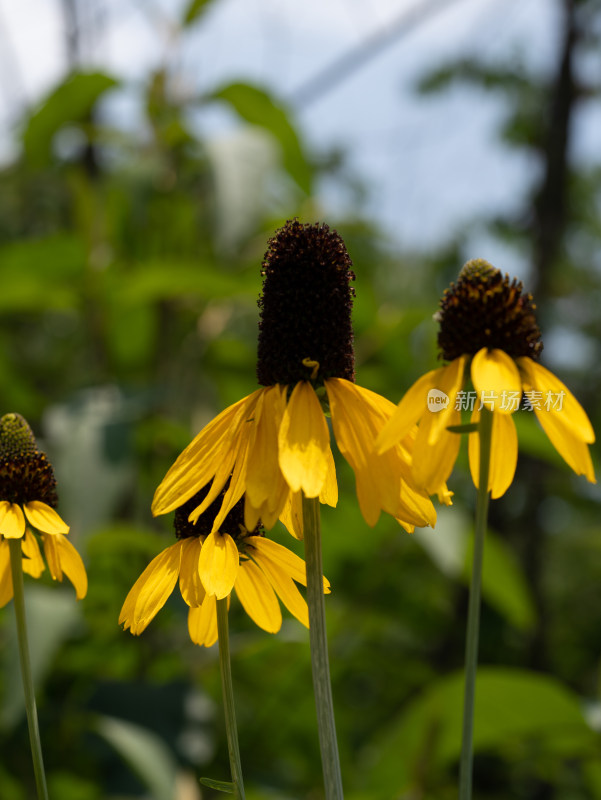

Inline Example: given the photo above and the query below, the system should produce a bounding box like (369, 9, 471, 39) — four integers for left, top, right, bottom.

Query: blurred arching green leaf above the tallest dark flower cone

(211, 83, 312, 194)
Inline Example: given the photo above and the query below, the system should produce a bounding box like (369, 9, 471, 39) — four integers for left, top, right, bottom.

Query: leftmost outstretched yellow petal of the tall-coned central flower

(152, 389, 263, 516)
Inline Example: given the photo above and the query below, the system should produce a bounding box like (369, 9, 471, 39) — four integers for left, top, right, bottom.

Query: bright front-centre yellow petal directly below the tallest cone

(278, 381, 330, 497)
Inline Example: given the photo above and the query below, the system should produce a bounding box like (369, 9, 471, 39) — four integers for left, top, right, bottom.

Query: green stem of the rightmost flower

(459, 408, 493, 800)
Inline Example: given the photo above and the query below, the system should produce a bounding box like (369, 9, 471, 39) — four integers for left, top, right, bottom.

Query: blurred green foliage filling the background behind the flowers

(0, 0, 601, 800)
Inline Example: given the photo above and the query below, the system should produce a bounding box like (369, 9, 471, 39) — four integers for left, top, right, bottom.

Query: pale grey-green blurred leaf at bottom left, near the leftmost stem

(94, 716, 177, 800)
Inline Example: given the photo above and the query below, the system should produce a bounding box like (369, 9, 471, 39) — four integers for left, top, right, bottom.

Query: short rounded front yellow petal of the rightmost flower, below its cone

(472, 347, 522, 414)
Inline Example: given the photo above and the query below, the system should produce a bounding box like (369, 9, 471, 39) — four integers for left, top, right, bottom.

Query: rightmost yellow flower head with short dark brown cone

(377, 259, 595, 498)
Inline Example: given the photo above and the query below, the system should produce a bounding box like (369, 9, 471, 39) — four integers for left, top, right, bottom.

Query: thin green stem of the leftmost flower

(8, 539, 48, 800)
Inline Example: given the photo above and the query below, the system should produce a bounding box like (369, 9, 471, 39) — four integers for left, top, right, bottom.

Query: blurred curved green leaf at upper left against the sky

(23, 72, 117, 167)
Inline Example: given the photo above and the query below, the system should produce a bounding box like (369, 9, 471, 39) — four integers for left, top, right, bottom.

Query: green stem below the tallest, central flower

(303, 493, 344, 800)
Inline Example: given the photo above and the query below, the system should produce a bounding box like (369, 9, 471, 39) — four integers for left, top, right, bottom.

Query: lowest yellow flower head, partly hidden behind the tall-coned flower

(119, 490, 329, 647)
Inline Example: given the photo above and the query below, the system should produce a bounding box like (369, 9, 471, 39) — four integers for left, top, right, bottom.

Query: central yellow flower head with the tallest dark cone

(152, 220, 440, 538)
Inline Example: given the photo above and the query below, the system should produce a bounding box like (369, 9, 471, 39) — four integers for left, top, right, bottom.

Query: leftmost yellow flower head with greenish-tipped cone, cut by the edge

(0, 413, 88, 607)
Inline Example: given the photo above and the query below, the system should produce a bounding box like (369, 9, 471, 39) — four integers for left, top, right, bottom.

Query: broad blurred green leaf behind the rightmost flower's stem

(366, 667, 595, 800)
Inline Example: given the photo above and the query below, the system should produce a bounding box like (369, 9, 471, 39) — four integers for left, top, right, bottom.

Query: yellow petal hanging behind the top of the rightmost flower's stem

(468, 408, 518, 500)
